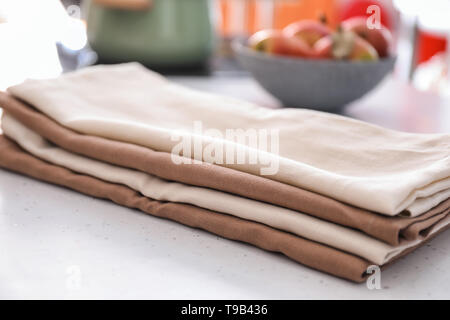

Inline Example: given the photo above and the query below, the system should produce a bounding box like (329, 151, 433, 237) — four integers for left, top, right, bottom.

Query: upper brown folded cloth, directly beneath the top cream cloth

(0, 92, 450, 245)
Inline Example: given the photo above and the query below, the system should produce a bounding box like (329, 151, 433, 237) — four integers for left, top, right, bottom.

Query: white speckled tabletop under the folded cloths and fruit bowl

(0, 77, 450, 299)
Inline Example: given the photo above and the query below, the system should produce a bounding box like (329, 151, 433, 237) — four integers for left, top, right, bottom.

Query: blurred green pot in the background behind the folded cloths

(84, 0, 214, 68)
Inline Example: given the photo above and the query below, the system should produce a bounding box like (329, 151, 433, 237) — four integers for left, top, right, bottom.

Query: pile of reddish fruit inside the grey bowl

(248, 17, 392, 61)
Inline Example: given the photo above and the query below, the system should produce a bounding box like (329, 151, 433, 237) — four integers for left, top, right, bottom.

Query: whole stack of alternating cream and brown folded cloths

(0, 63, 450, 282)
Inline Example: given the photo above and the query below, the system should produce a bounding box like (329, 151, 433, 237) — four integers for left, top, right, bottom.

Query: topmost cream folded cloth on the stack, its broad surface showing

(8, 63, 450, 216)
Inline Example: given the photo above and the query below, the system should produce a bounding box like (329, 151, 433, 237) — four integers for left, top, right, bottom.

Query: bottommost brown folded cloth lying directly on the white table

(0, 135, 370, 282)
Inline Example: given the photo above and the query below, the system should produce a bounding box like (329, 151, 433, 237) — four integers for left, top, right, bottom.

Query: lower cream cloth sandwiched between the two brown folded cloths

(2, 114, 445, 265)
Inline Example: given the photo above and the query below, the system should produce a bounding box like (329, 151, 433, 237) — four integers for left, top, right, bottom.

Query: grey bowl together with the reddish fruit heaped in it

(233, 16, 395, 112)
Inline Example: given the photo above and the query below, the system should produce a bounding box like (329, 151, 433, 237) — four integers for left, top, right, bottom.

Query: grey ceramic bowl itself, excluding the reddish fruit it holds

(233, 41, 395, 111)
